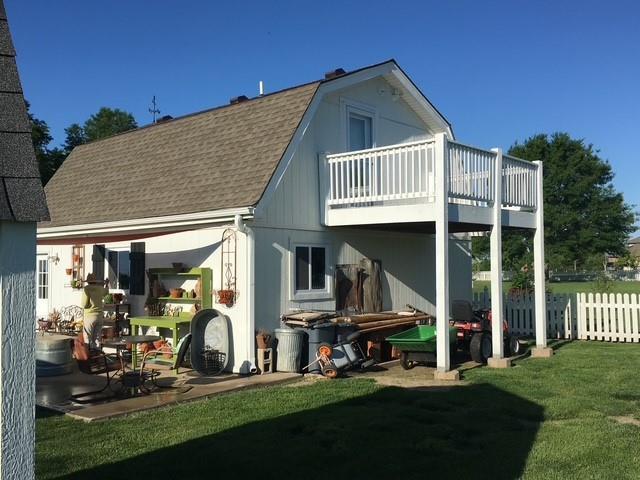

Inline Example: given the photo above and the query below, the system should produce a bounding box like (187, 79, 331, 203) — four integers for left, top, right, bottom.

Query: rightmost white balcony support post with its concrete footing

(531, 161, 553, 357)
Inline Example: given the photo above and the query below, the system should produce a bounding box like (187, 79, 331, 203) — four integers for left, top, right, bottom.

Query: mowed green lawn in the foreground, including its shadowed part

(36, 342, 640, 479)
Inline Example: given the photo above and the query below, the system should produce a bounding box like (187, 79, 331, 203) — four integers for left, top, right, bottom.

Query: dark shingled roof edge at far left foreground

(0, 0, 49, 222)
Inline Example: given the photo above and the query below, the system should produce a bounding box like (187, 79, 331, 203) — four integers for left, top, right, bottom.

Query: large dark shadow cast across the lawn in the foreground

(58, 384, 543, 480)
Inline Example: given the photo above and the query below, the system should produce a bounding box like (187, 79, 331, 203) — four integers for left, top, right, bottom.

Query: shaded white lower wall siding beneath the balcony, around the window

(255, 227, 471, 329)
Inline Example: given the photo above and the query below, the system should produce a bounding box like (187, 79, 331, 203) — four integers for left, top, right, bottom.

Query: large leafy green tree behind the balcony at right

(474, 133, 636, 270)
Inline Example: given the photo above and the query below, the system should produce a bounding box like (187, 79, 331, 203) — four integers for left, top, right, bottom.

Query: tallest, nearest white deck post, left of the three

(435, 133, 451, 374)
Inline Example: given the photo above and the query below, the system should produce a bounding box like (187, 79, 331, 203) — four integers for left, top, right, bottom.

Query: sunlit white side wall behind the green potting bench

(34, 226, 253, 372)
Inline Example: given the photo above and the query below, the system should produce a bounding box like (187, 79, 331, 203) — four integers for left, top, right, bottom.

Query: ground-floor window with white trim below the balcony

(292, 245, 331, 298)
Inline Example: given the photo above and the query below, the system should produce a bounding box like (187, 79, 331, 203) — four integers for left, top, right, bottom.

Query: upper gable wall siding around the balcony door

(256, 78, 432, 229)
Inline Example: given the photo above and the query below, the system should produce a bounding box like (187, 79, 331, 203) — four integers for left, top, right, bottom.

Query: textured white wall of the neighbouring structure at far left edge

(0, 222, 36, 479)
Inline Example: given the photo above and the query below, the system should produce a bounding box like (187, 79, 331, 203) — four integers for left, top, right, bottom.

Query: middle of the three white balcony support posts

(491, 148, 504, 360)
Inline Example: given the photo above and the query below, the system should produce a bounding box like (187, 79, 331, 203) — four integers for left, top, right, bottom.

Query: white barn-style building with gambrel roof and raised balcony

(38, 60, 546, 374)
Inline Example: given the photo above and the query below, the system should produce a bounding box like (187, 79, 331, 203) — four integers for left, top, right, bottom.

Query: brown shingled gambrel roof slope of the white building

(40, 82, 320, 227)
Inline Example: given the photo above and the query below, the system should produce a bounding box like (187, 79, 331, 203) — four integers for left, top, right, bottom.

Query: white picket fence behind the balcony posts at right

(473, 290, 640, 343)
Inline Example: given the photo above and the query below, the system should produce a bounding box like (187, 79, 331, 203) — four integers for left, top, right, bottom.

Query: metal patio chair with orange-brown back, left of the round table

(71, 334, 122, 404)
